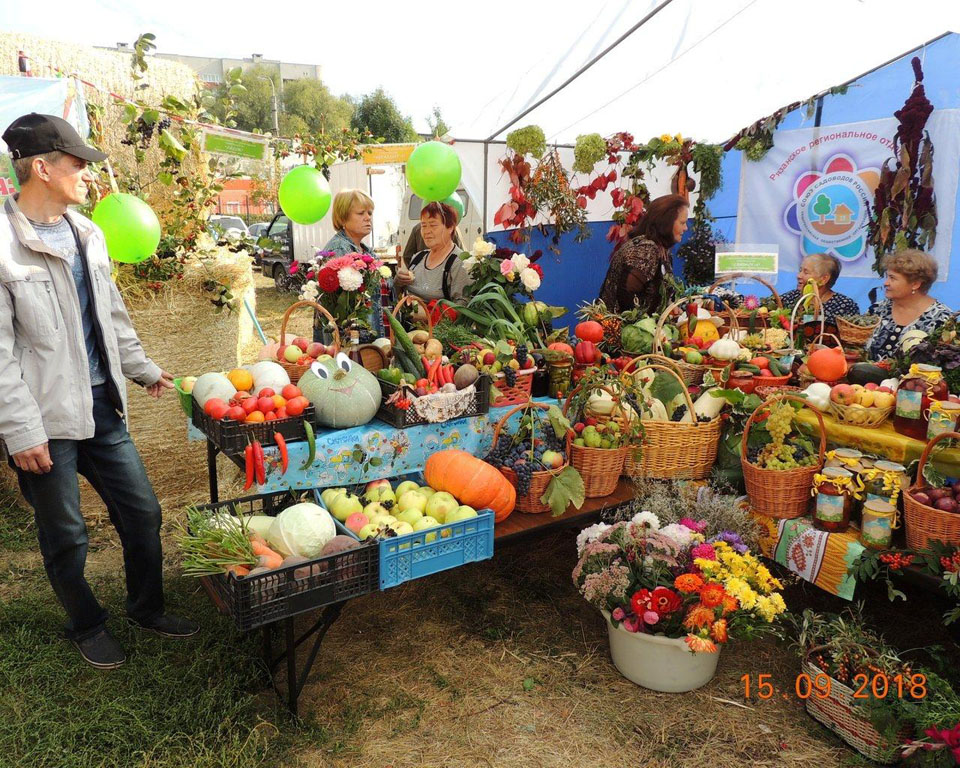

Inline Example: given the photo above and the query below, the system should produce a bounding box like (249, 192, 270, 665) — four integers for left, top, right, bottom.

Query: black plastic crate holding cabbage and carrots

(198, 491, 380, 632)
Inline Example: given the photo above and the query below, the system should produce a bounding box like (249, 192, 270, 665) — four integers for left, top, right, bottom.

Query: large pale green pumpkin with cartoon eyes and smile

(297, 352, 380, 429)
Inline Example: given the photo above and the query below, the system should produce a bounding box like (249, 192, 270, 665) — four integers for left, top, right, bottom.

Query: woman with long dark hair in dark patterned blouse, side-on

(600, 195, 689, 314)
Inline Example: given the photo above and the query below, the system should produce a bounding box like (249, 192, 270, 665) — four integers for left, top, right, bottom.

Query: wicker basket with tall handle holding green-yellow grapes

(740, 394, 827, 520)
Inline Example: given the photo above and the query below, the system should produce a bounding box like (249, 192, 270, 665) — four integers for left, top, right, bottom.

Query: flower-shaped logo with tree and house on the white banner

(783, 154, 880, 261)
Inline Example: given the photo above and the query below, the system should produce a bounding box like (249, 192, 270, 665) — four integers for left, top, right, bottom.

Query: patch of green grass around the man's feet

(0, 580, 318, 768)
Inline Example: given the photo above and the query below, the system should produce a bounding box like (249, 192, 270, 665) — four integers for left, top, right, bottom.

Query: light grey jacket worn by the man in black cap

(0, 197, 161, 454)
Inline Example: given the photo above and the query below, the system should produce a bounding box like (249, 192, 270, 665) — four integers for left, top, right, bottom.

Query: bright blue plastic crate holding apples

(314, 478, 493, 589)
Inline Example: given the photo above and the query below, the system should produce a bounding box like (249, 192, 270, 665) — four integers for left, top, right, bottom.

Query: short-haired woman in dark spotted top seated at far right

(867, 248, 950, 360)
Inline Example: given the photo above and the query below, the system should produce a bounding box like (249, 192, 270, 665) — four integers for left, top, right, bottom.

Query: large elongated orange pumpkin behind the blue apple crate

(423, 448, 517, 523)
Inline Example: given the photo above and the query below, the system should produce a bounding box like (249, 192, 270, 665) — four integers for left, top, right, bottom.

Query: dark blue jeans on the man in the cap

(17, 385, 163, 639)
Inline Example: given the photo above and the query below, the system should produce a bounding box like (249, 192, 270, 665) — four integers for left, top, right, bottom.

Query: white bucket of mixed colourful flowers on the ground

(573, 512, 786, 692)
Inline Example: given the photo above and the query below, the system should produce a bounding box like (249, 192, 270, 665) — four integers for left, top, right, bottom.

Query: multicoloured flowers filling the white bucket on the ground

(573, 512, 786, 653)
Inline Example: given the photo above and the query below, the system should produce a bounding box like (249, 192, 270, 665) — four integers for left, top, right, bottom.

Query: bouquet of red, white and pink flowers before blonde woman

(290, 251, 390, 329)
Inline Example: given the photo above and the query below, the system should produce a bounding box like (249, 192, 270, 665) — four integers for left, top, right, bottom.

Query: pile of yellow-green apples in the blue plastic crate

(320, 480, 477, 544)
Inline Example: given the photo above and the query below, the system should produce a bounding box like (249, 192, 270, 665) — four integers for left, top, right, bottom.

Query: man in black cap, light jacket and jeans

(0, 113, 198, 669)
